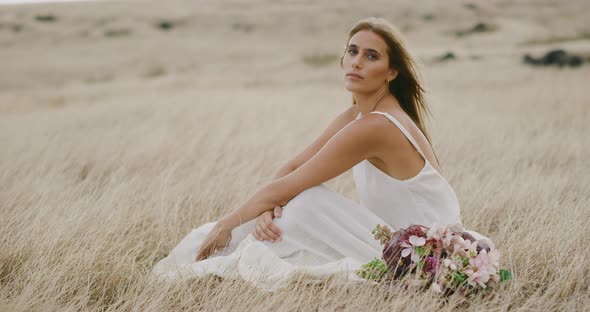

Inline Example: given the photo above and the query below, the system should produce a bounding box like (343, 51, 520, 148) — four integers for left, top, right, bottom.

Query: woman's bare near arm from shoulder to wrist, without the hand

(218, 114, 388, 229)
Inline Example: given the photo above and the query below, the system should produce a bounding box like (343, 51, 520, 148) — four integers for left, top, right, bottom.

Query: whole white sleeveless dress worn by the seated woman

(151, 112, 486, 291)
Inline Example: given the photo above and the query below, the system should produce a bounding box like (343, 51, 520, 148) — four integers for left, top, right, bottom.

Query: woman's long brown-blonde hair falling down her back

(340, 17, 438, 167)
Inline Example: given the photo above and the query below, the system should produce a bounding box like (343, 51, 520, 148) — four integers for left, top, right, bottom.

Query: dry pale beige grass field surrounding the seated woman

(0, 1, 590, 311)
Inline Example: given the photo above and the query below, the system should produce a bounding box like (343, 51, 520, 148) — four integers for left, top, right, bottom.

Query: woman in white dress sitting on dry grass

(154, 18, 484, 290)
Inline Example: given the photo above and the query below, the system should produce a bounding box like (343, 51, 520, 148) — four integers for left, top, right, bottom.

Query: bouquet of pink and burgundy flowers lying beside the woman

(355, 224, 512, 296)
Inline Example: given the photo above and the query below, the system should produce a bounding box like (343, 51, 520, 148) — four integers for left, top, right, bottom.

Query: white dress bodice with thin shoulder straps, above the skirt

(353, 111, 461, 229)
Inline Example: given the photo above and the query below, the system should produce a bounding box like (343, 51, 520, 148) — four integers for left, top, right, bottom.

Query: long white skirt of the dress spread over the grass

(152, 184, 386, 291)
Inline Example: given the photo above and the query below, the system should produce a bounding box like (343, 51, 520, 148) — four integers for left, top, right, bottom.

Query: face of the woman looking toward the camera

(342, 30, 397, 93)
